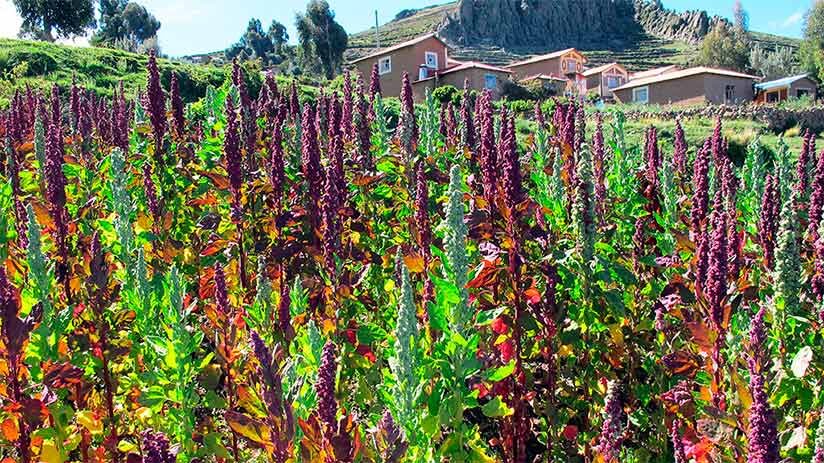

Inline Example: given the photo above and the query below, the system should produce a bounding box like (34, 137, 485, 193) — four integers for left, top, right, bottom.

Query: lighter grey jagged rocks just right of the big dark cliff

(635, 0, 727, 44)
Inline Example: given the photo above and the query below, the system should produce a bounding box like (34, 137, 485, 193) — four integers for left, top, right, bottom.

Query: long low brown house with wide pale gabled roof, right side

(612, 66, 758, 105)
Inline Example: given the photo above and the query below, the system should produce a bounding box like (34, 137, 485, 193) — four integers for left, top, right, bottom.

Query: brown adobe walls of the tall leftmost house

(355, 37, 447, 96)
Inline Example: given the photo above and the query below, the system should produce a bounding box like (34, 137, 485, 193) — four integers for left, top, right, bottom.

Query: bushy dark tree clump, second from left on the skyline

(91, 0, 160, 51)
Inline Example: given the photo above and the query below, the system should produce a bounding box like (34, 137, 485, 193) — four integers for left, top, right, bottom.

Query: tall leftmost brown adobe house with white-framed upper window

(351, 34, 450, 100)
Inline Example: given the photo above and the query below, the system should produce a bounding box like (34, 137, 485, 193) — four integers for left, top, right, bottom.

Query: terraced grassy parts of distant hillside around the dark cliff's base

(346, 2, 799, 70)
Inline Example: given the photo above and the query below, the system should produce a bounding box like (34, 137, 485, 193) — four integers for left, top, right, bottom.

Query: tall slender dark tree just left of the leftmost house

(295, 0, 349, 79)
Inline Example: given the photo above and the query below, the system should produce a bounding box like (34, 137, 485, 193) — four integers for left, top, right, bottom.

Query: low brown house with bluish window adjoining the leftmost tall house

(412, 61, 512, 101)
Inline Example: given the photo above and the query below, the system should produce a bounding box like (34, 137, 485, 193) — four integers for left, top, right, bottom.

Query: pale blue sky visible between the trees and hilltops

(0, 0, 812, 56)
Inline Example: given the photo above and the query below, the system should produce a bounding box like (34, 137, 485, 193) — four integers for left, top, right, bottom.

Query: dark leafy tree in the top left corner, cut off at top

(13, 0, 96, 42)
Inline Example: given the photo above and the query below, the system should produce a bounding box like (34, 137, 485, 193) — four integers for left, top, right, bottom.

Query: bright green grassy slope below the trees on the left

(0, 39, 227, 106)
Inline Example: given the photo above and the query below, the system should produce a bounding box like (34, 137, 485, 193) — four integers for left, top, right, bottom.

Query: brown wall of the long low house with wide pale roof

(614, 74, 753, 105)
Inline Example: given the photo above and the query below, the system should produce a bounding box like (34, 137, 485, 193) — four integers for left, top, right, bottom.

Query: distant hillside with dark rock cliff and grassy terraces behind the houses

(346, 0, 798, 69)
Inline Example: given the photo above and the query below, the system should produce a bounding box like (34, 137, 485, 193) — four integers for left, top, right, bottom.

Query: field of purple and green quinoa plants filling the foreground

(0, 55, 824, 463)
